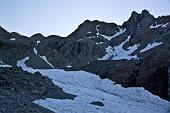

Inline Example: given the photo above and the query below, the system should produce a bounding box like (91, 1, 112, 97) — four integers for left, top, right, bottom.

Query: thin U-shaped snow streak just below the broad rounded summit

(96, 25, 126, 41)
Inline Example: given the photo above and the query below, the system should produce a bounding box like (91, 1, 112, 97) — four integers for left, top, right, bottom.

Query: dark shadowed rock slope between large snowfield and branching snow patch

(81, 60, 168, 100)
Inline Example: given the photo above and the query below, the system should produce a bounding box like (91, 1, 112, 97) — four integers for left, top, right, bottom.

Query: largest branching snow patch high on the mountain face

(98, 36, 139, 60)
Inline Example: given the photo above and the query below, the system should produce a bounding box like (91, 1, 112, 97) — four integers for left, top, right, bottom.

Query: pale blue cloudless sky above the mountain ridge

(0, 0, 170, 36)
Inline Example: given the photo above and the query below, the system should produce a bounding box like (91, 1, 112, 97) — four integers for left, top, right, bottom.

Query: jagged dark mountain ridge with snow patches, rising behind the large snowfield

(0, 10, 170, 99)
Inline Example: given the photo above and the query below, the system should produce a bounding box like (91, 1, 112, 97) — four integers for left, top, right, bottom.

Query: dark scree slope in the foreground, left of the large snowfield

(0, 67, 75, 113)
